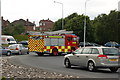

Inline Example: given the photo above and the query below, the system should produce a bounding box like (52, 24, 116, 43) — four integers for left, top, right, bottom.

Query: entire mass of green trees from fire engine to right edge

(54, 10, 120, 44)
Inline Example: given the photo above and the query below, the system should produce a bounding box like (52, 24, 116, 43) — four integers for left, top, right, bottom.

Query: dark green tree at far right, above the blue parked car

(93, 11, 120, 43)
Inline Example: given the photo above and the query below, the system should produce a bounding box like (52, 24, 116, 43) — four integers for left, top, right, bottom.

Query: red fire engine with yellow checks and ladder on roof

(28, 30, 78, 55)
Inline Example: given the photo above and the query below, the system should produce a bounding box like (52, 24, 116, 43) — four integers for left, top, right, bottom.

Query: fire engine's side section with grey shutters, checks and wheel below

(44, 35, 65, 55)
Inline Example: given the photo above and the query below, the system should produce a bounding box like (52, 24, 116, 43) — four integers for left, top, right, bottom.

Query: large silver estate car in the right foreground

(64, 47, 120, 72)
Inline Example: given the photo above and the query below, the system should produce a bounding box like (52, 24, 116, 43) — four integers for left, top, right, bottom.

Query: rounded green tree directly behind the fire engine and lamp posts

(54, 13, 94, 42)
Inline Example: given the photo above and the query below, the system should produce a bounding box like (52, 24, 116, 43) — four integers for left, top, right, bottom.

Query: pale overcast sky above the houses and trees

(1, 0, 120, 24)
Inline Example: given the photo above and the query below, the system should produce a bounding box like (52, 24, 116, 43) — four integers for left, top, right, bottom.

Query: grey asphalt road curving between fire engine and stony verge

(8, 53, 120, 78)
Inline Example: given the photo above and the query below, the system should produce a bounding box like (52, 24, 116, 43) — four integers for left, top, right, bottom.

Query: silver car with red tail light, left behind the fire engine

(8, 44, 29, 55)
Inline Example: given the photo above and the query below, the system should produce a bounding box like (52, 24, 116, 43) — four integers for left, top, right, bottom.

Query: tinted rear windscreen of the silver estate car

(103, 48, 119, 55)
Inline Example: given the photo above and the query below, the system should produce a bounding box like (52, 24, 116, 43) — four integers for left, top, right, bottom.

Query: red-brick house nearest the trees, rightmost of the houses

(36, 19, 54, 31)
